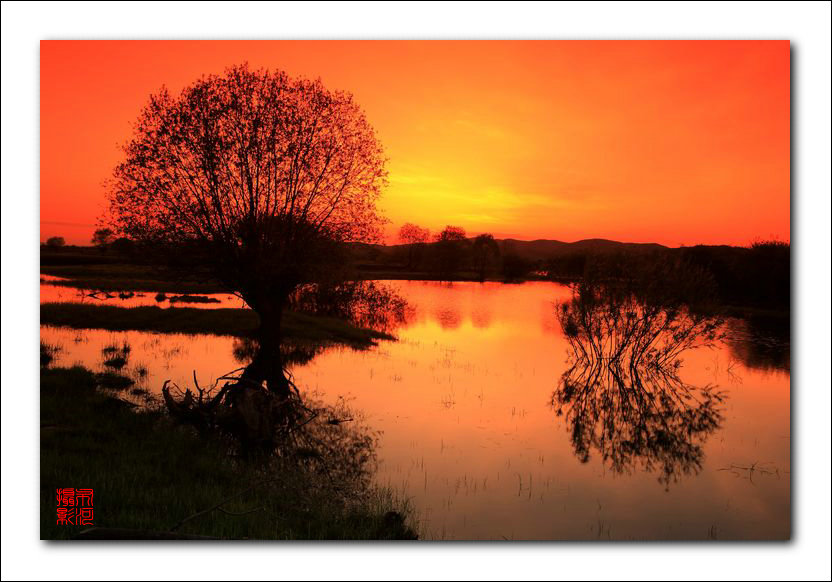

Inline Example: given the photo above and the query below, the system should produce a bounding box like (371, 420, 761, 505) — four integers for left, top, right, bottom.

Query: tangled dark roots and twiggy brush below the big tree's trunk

(162, 340, 380, 506)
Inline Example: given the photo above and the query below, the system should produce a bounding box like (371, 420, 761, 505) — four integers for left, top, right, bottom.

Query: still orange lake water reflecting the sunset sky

(41, 281, 791, 540)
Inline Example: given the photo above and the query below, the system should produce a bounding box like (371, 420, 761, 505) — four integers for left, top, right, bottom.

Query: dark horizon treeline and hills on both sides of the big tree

(41, 223, 791, 320)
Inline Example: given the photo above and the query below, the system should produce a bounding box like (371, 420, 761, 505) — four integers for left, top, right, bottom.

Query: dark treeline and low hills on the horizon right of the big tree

(368, 224, 791, 312)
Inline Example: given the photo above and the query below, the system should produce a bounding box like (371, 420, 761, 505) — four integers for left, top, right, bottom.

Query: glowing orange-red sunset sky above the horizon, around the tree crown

(40, 41, 790, 246)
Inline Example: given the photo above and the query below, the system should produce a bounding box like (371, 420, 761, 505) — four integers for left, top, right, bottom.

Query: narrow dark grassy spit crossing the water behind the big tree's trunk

(40, 303, 392, 347)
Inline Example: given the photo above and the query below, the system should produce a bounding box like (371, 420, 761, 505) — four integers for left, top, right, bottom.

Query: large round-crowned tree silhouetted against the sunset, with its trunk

(108, 65, 386, 397)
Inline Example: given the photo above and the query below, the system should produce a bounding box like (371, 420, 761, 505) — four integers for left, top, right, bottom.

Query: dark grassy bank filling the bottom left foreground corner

(40, 367, 412, 540)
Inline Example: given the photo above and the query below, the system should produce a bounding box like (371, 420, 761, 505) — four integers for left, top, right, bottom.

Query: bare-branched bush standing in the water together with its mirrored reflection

(552, 284, 724, 488)
